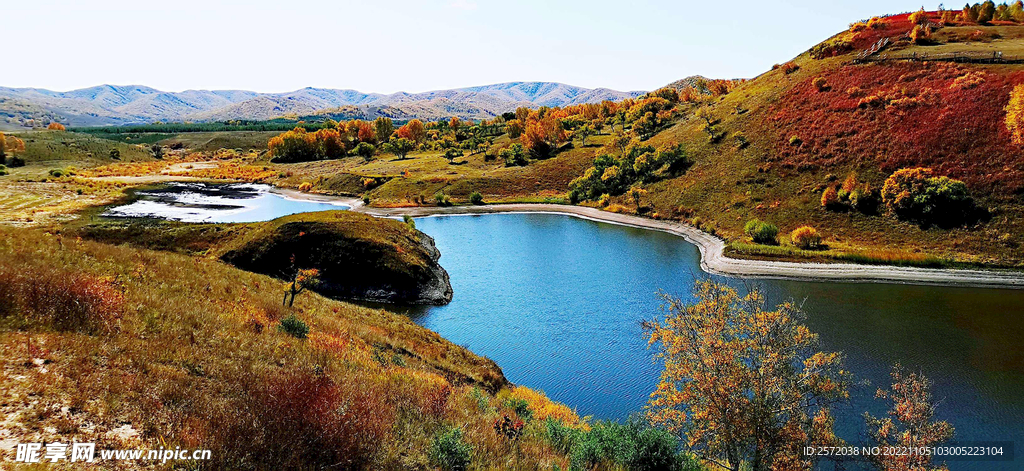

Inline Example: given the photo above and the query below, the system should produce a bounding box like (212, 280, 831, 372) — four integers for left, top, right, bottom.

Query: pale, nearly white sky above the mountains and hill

(6, 0, 937, 93)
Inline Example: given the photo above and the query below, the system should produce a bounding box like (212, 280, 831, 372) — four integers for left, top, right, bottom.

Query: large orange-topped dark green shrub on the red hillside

(882, 167, 975, 224)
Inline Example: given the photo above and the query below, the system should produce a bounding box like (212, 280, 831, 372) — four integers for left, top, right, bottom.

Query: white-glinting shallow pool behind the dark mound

(102, 183, 348, 222)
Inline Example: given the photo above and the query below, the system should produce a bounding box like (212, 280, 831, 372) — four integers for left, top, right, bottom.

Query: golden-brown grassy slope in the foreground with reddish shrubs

(0, 224, 606, 469)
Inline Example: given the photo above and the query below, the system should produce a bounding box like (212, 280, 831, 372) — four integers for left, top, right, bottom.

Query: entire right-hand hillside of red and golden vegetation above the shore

(634, 11, 1024, 267)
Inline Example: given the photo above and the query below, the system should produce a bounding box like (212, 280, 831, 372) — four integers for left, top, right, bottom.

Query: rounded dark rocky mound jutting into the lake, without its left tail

(221, 211, 453, 304)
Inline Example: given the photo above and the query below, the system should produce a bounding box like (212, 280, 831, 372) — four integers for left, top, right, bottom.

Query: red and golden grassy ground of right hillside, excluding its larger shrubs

(649, 13, 1024, 265)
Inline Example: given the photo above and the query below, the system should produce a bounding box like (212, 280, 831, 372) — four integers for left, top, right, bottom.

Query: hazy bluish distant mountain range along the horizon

(0, 82, 644, 129)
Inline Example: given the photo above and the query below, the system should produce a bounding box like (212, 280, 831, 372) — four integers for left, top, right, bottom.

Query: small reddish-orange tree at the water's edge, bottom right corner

(864, 365, 953, 471)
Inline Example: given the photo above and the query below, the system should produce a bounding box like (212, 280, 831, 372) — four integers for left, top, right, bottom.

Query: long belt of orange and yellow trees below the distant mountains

(268, 79, 740, 166)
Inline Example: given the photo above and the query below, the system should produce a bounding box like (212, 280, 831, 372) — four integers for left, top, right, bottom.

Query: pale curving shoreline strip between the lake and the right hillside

(274, 188, 1024, 289)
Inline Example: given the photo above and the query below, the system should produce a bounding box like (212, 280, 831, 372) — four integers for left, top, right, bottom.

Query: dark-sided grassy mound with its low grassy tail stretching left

(73, 211, 452, 297)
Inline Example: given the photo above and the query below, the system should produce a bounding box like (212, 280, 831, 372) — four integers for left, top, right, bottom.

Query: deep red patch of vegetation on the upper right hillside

(767, 62, 1024, 196)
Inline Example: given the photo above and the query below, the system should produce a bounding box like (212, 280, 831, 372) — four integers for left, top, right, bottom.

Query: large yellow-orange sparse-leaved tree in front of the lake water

(644, 280, 850, 471)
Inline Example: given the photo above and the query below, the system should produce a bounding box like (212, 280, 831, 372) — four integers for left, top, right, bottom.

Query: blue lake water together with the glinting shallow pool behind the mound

(109, 185, 1024, 470)
